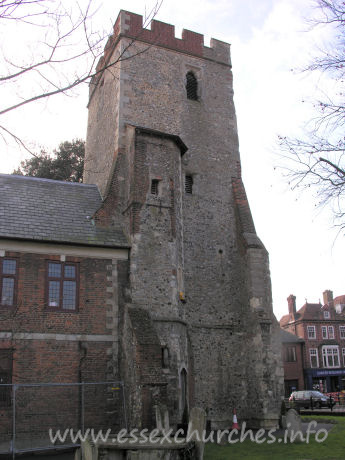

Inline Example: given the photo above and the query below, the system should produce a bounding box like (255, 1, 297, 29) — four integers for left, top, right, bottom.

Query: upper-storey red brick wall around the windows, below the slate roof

(0, 252, 111, 334)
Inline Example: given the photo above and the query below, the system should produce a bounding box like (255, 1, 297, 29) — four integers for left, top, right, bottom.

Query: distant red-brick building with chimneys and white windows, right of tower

(280, 290, 345, 393)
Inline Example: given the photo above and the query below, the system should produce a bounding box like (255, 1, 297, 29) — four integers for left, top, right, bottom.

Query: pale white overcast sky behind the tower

(0, 0, 345, 320)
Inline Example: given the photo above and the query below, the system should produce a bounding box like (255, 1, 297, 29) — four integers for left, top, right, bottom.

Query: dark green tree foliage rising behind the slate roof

(13, 139, 85, 182)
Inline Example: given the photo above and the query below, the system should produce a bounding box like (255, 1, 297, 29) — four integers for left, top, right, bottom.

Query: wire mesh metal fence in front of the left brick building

(0, 382, 127, 458)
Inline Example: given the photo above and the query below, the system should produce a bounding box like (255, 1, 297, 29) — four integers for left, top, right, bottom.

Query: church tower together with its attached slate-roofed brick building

(0, 11, 283, 434)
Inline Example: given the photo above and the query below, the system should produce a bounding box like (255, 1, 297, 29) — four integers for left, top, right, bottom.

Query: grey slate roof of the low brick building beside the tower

(0, 174, 129, 248)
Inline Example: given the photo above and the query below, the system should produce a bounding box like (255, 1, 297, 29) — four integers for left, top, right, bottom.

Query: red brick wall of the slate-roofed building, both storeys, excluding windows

(0, 252, 117, 442)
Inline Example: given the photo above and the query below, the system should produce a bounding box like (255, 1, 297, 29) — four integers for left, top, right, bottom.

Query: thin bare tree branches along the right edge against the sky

(278, 0, 345, 229)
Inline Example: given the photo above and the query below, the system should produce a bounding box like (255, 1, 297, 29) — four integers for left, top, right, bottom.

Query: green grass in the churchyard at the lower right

(204, 416, 345, 460)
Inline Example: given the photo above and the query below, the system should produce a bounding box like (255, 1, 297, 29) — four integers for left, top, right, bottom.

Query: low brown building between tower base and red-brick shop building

(280, 329, 304, 398)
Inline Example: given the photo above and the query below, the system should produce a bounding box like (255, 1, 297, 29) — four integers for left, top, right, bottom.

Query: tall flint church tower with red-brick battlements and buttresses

(84, 11, 283, 429)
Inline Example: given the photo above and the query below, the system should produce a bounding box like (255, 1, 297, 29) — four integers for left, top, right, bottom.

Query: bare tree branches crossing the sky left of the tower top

(0, 0, 162, 153)
